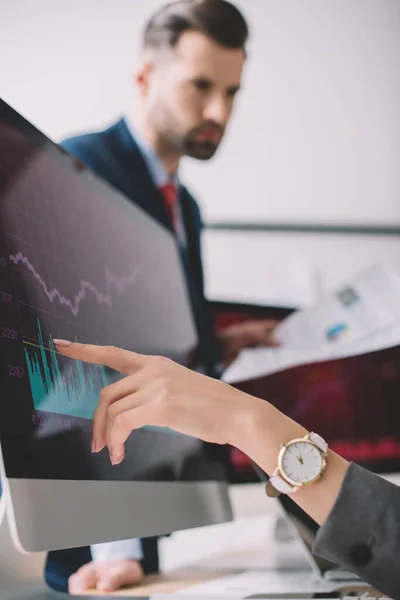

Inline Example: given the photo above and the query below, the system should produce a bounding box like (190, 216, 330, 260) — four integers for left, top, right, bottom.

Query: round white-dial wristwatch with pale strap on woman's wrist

(265, 432, 328, 497)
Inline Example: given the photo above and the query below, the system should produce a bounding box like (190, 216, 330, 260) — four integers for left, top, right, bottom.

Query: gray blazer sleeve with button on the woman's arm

(313, 464, 400, 598)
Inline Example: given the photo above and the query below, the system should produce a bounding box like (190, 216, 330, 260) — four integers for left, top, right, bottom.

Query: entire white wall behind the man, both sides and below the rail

(0, 0, 400, 296)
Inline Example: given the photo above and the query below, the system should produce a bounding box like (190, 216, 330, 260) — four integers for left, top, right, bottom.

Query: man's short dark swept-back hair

(144, 0, 249, 50)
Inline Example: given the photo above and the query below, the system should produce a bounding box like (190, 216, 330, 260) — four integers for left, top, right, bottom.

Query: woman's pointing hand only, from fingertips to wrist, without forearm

(54, 340, 265, 464)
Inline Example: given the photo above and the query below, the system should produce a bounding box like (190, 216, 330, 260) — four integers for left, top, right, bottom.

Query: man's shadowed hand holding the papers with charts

(219, 319, 279, 365)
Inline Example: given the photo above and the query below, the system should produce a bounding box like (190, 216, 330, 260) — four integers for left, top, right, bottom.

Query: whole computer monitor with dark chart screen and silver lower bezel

(0, 101, 232, 551)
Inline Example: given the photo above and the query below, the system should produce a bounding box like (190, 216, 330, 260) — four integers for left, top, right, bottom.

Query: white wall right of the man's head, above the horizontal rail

(188, 0, 400, 223)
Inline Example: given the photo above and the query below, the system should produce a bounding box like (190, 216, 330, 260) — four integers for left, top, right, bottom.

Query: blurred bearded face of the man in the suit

(141, 31, 245, 160)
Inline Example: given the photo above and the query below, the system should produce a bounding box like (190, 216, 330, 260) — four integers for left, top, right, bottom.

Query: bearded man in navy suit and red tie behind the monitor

(46, 0, 273, 593)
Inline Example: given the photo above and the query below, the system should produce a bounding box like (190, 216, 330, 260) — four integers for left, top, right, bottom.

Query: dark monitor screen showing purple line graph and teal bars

(0, 97, 225, 480)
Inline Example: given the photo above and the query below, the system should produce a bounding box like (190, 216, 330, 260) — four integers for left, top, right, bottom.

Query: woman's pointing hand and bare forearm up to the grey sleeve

(53, 340, 348, 523)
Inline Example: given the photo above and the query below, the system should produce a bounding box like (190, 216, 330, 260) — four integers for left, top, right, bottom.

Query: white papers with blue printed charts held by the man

(223, 267, 400, 383)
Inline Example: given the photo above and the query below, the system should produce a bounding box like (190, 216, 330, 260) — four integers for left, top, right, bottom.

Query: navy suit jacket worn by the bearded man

(45, 119, 219, 591)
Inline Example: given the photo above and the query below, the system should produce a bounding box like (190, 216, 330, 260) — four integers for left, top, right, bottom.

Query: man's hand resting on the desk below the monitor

(68, 559, 144, 595)
